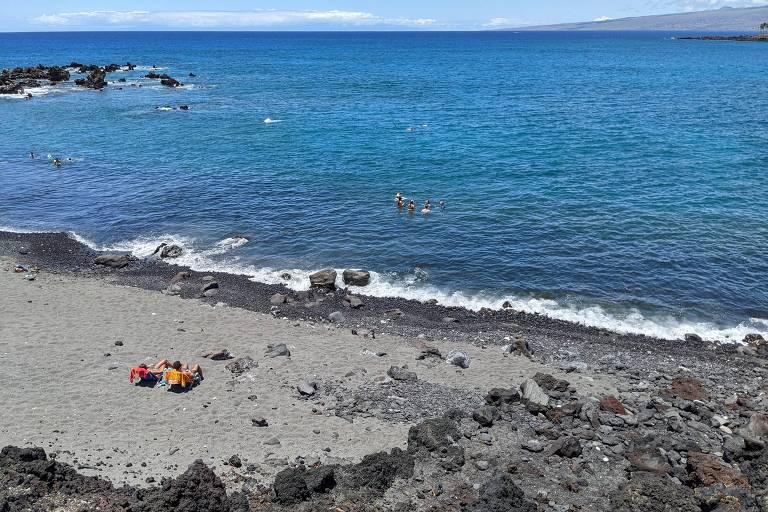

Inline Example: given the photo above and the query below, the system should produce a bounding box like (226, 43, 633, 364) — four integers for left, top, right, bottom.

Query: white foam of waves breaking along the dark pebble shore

(52, 228, 768, 343)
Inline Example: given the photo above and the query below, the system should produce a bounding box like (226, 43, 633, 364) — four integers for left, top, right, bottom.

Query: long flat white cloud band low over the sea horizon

(33, 10, 437, 28)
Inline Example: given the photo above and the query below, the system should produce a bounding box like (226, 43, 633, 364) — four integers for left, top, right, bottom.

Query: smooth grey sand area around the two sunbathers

(0, 259, 616, 484)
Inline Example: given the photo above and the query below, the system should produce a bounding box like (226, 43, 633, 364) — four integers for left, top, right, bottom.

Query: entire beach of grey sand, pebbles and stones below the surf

(0, 232, 768, 511)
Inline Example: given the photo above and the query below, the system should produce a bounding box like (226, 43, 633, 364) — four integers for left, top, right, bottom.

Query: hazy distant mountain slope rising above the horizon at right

(509, 6, 768, 32)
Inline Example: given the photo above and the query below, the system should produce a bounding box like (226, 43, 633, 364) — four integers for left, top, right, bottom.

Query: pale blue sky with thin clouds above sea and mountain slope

(0, 0, 768, 32)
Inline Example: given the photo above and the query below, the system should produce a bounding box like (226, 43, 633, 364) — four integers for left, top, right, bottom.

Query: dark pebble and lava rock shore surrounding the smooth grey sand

(0, 232, 768, 512)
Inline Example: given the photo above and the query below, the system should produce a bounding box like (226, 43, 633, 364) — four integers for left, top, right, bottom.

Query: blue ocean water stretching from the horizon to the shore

(0, 33, 768, 339)
